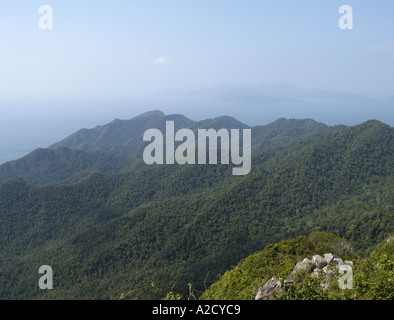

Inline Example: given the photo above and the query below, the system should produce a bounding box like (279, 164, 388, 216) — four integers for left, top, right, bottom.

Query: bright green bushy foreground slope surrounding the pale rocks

(200, 232, 394, 300)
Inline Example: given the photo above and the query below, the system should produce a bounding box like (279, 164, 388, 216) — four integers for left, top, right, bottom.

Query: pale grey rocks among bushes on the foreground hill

(255, 253, 353, 300)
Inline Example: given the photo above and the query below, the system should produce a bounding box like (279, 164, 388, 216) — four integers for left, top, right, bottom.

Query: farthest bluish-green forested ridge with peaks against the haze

(49, 110, 345, 158)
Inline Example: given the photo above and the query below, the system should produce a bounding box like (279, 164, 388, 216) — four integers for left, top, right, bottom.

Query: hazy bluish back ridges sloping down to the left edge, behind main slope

(0, 111, 344, 185)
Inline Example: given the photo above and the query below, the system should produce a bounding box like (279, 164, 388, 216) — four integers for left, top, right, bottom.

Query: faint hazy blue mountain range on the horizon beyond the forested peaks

(148, 82, 394, 126)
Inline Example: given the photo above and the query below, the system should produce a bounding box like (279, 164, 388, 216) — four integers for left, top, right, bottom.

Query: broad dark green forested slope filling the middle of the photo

(0, 113, 394, 299)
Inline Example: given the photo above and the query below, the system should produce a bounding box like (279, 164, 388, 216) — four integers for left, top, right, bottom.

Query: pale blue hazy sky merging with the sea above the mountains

(0, 0, 394, 162)
